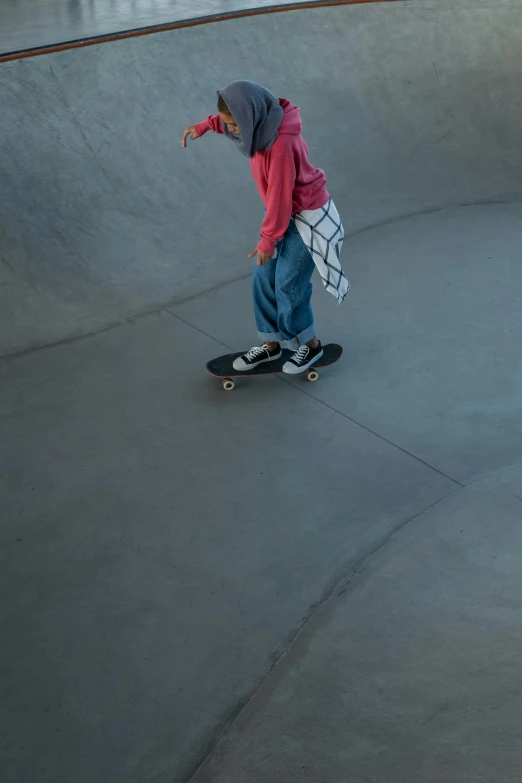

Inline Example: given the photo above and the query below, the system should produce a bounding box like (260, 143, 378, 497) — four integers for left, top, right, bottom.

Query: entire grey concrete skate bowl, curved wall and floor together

(0, 0, 522, 783)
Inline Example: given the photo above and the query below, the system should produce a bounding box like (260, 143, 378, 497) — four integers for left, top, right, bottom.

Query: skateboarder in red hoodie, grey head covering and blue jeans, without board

(182, 81, 350, 374)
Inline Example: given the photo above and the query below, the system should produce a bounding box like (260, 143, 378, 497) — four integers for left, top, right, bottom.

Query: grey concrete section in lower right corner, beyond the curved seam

(192, 469, 522, 783)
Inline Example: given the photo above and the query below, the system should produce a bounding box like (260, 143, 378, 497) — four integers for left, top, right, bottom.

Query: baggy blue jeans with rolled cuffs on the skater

(252, 220, 315, 350)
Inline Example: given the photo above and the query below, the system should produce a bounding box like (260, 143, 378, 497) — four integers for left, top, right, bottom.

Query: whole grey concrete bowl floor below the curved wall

(0, 205, 522, 783)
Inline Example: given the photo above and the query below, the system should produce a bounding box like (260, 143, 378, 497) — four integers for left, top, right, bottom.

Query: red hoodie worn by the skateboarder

(195, 98, 330, 254)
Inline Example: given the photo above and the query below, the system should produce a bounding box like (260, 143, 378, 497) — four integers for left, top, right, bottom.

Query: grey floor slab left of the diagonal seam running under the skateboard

(0, 304, 457, 783)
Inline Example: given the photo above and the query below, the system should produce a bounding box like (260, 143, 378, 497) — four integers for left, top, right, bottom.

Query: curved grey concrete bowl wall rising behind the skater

(0, 0, 522, 354)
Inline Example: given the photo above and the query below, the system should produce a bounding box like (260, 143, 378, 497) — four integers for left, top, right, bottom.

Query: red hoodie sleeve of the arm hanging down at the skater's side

(257, 155, 296, 254)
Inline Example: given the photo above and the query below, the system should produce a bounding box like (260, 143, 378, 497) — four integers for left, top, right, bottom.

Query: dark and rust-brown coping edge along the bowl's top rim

(0, 0, 406, 63)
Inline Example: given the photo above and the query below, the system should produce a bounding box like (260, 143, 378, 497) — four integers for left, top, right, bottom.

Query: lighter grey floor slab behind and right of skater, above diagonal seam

(173, 204, 522, 484)
